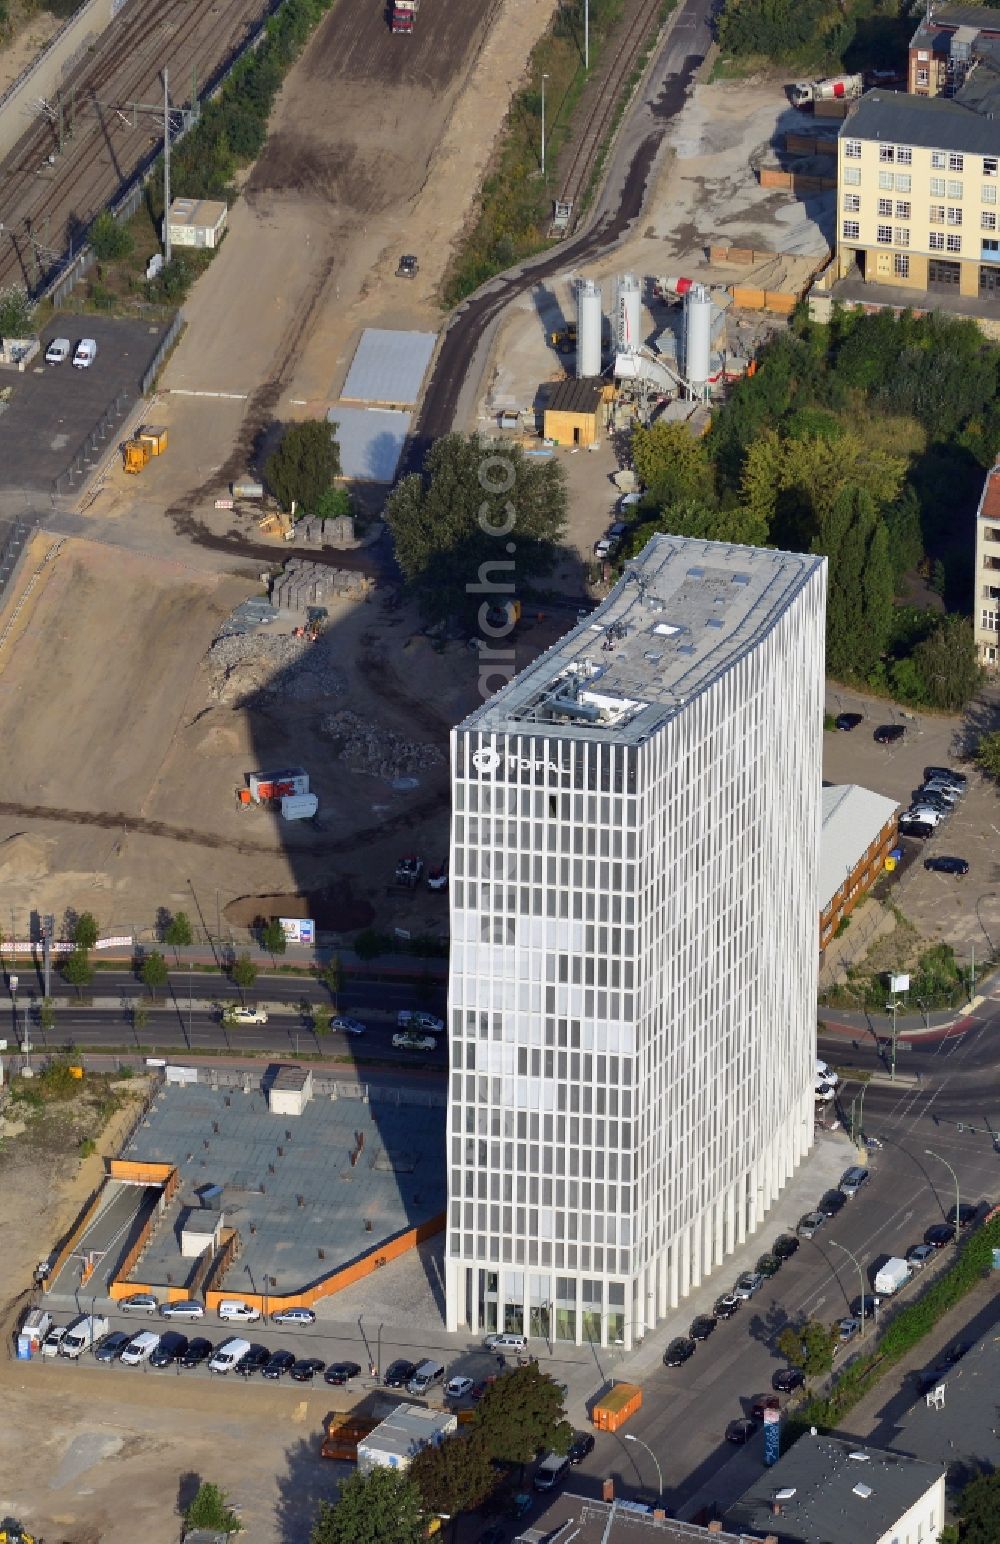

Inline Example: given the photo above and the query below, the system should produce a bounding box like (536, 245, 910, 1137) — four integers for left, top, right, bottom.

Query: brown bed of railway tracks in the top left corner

(0, 0, 269, 290)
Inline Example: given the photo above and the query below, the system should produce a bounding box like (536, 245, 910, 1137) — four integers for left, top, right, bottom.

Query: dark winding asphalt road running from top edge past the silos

(407, 0, 713, 453)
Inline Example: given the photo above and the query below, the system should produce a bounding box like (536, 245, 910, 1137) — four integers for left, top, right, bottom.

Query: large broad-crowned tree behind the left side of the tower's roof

(386, 434, 566, 623)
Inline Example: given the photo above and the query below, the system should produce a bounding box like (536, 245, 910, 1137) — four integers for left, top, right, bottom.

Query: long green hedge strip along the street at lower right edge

(795, 1215, 1000, 1430)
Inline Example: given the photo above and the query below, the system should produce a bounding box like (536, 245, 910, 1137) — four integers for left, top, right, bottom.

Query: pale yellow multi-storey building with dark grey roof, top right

(836, 85, 1000, 301)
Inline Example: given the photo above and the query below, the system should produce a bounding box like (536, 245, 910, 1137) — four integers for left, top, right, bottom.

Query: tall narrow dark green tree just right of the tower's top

(812, 488, 894, 681)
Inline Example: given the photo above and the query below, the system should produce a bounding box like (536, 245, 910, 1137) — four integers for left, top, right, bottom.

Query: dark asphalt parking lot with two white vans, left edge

(0, 315, 167, 493)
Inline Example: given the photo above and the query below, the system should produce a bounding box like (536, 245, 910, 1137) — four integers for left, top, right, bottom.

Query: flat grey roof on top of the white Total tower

(460, 536, 826, 744)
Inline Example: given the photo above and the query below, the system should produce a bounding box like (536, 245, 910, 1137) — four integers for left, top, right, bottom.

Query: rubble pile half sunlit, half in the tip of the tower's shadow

(205, 633, 347, 704)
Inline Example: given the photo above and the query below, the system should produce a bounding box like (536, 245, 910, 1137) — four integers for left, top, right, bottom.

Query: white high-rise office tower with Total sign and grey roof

(446, 536, 826, 1345)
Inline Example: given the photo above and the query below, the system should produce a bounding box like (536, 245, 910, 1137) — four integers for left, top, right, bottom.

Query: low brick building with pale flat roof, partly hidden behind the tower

(819, 783, 900, 950)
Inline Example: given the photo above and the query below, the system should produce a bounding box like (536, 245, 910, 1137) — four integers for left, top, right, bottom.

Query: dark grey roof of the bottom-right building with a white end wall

(725, 1436, 946, 1544)
